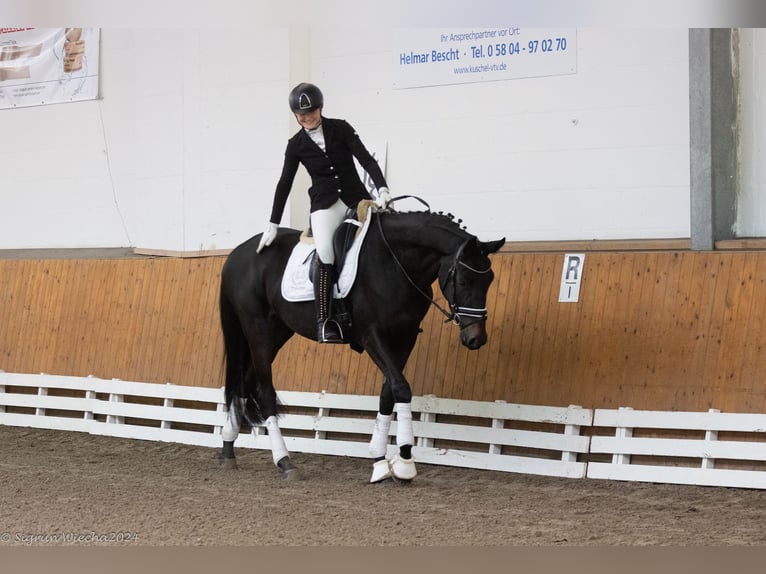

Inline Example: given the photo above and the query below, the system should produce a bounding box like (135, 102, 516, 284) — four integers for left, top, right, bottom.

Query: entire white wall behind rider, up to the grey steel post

(0, 27, 712, 250)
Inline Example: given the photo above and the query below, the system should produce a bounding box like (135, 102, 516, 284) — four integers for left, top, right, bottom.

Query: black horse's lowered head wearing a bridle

(439, 237, 505, 350)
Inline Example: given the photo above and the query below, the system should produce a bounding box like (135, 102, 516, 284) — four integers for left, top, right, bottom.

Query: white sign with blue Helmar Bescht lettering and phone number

(392, 26, 577, 89)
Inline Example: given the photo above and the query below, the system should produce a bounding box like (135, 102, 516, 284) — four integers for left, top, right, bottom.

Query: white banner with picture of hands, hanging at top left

(0, 28, 99, 108)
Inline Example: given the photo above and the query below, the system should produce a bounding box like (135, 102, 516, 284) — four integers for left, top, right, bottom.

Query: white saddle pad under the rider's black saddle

(282, 210, 372, 303)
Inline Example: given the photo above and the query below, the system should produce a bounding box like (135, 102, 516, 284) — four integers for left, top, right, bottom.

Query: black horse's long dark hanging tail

(219, 288, 264, 425)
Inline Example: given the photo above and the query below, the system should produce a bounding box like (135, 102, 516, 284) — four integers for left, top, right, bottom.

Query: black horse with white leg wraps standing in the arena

(220, 200, 505, 482)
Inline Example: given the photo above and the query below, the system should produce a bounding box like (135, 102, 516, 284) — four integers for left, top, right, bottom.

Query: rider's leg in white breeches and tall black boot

(311, 199, 346, 343)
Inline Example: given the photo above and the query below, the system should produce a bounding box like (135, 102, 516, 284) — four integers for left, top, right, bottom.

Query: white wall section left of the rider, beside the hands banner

(0, 29, 290, 251)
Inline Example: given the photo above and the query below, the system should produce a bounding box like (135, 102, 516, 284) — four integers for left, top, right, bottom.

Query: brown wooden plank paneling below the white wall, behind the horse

(7, 251, 766, 412)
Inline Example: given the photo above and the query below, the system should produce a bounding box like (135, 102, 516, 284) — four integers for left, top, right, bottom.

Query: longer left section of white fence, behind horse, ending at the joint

(0, 372, 593, 478)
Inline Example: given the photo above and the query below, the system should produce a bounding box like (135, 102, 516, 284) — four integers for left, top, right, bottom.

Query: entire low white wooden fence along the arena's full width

(0, 372, 766, 489)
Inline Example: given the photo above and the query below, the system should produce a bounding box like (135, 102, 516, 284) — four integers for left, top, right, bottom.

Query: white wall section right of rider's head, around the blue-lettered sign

(318, 29, 690, 240)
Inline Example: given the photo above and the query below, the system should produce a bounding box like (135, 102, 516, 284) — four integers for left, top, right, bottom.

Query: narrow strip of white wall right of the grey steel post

(737, 28, 766, 237)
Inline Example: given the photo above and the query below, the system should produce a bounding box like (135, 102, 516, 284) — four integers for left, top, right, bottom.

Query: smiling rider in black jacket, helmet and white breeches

(257, 82, 391, 343)
